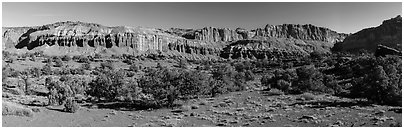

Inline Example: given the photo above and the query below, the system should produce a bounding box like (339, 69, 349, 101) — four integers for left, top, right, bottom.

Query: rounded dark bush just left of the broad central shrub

(86, 69, 125, 101)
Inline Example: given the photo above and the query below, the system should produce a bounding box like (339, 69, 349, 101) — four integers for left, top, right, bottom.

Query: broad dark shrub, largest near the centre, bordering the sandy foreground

(138, 68, 208, 107)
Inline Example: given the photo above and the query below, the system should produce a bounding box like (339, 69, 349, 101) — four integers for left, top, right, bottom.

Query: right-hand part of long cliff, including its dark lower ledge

(167, 24, 347, 59)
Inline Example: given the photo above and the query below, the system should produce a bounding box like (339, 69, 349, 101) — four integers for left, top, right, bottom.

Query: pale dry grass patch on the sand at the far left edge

(2, 101, 34, 117)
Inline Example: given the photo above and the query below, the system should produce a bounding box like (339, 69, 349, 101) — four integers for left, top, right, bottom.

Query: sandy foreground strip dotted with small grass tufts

(2, 90, 402, 127)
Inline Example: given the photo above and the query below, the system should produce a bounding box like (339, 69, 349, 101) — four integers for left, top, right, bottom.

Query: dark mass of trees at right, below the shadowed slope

(261, 54, 402, 105)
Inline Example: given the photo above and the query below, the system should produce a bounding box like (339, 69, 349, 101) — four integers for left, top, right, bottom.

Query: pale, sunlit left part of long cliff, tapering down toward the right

(3, 21, 220, 58)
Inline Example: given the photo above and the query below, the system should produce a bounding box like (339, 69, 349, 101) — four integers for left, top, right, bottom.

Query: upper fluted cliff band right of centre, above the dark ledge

(170, 24, 347, 43)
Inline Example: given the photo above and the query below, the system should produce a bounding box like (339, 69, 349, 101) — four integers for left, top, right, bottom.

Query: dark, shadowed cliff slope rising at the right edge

(333, 15, 402, 52)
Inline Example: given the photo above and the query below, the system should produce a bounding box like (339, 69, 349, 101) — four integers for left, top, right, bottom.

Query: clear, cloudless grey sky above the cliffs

(2, 2, 402, 33)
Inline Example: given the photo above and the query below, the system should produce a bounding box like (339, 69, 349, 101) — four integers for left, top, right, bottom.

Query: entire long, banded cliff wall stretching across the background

(2, 21, 347, 58)
